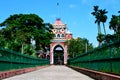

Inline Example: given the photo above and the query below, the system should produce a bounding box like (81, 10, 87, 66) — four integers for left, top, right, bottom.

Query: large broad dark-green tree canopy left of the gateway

(0, 14, 53, 55)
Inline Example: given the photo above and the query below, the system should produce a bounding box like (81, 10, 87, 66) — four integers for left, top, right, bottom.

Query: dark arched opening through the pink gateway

(54, 45, 64, 65)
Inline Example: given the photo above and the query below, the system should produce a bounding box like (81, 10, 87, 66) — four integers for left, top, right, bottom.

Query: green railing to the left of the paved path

(0, 47, 49, 71)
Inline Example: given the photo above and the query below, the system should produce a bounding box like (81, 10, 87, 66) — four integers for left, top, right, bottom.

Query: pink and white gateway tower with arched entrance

(50, 19, 72, 64)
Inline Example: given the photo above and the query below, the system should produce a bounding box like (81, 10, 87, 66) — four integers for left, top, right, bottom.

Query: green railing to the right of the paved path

(68, 40, 120, 74)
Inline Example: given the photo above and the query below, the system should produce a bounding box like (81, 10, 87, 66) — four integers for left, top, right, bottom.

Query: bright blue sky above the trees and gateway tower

(0, 0, 120, 46)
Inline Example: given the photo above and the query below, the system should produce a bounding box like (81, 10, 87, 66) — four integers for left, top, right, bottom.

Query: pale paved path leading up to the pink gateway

(3, 65, 94, 80)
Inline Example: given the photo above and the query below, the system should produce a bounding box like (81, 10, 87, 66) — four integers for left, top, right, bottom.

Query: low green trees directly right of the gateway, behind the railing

(66, 38, 93, 58)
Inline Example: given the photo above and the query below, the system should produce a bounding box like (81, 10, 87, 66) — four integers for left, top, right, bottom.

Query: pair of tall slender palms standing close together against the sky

(91, 6, 107, 45)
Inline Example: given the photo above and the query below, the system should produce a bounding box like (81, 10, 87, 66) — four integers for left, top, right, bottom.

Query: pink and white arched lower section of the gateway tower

(50, 42, 67, 64)
